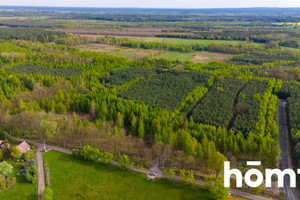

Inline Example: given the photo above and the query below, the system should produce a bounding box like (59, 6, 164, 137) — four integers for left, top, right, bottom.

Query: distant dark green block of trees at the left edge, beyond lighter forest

(0, 27, 66, 42)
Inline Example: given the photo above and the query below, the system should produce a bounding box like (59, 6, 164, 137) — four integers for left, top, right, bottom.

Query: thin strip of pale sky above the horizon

(0, 0, 300, 8)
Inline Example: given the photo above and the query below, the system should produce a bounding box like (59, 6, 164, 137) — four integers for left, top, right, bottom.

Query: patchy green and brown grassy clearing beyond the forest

(77, 44, 228, 63)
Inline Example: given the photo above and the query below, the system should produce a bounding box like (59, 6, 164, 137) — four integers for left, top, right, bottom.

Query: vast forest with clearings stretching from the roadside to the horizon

(0, 8, 300, 200)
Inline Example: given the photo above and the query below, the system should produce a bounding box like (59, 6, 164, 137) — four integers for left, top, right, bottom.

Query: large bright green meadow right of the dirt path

(44, 151, 212, 200)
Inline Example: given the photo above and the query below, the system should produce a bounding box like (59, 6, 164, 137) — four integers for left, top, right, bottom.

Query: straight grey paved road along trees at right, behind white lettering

(279, 100, 296, 200)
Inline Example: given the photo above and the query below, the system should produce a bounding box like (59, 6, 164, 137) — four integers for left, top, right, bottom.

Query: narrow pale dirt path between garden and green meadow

(36, 145, 45, 200)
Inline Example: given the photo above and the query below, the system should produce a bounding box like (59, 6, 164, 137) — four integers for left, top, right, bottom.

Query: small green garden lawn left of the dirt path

(0, 162, 38, 200)
